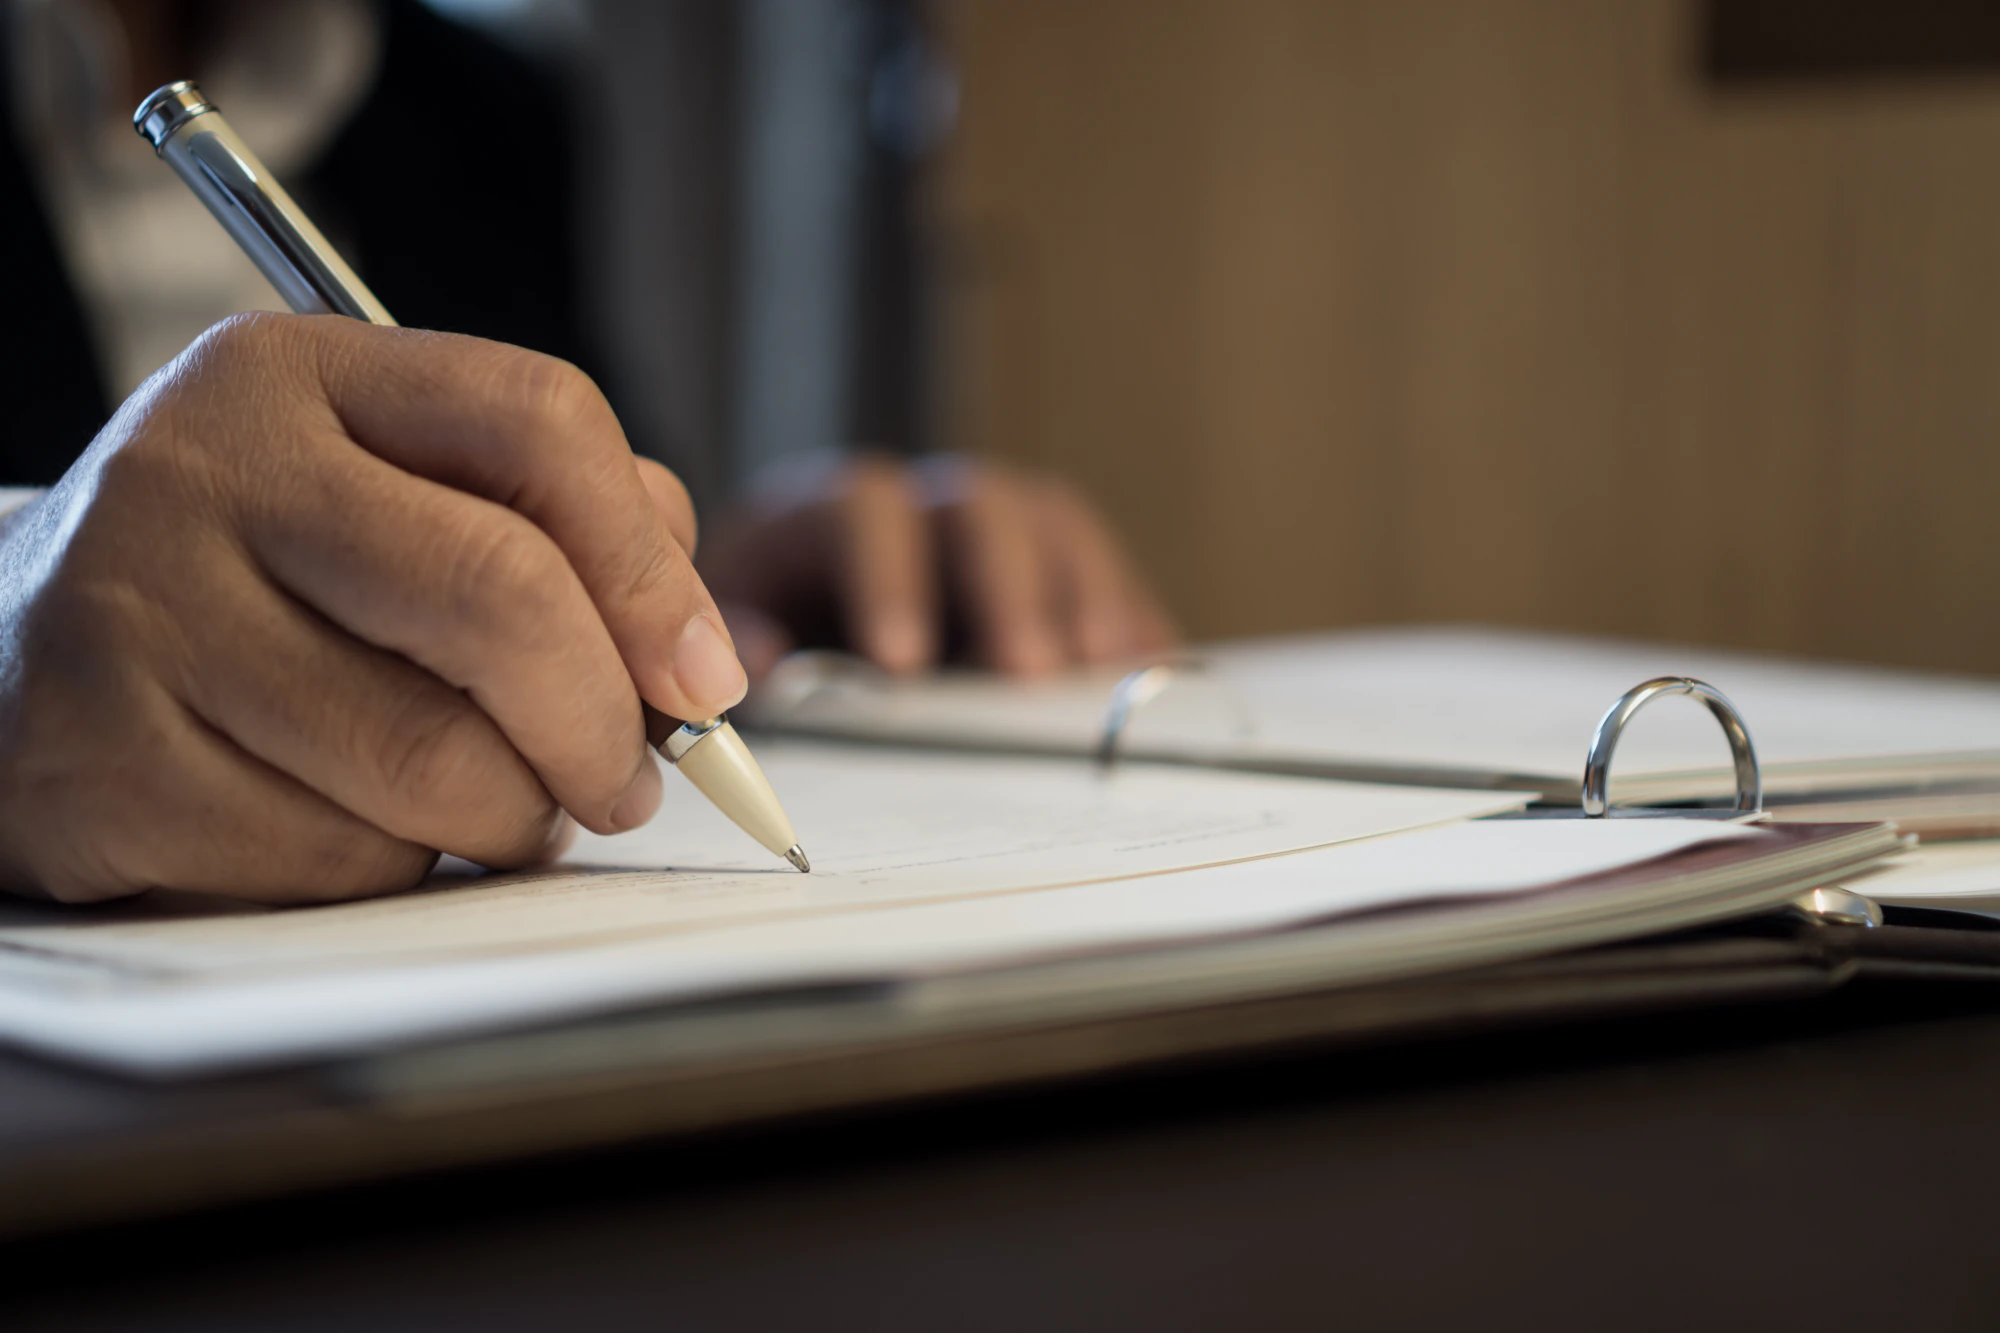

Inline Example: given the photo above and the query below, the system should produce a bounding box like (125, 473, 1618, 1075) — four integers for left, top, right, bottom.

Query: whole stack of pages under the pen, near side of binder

(0, 743, 1898, 1073)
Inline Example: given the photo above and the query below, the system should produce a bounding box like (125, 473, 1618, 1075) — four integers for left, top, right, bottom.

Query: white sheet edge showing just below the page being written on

(0, 821, 1746, 1075)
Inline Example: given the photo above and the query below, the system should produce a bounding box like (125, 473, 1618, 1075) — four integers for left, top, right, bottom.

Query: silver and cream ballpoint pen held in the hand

(132, 80, 812, 871)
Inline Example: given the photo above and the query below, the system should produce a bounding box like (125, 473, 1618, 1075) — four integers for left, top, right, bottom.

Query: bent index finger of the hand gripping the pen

(318, 316, 748, 719)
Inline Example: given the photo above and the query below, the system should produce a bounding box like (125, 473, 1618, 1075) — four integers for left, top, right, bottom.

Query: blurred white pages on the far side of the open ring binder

(766, 626, 2000, 795)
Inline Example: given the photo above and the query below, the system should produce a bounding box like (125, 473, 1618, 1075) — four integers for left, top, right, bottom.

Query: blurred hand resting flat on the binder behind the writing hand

(702, 458, 1174, 677)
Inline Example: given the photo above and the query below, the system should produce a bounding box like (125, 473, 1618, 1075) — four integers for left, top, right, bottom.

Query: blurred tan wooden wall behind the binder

(932, 0, 2000, 671)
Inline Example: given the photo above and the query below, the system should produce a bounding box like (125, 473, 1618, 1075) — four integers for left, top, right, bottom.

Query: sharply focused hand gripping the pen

(0, 314, 744, 903)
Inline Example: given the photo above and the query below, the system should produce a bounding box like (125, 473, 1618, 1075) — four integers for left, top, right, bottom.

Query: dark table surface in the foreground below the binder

(0, 985, 2000, 1333)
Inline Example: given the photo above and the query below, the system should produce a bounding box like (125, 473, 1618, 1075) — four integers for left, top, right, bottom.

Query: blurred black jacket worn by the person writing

(0, 0, 592, 486)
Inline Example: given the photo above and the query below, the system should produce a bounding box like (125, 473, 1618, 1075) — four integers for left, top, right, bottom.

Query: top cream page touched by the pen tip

(0, 741, 1520, 985)
